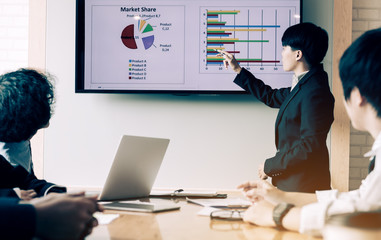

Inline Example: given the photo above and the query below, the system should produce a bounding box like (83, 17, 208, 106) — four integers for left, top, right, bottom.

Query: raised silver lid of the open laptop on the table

(99, 135, 169, 201)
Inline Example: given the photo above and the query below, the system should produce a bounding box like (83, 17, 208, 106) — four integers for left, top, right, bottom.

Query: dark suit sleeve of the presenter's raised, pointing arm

(234, 68, 290, 108)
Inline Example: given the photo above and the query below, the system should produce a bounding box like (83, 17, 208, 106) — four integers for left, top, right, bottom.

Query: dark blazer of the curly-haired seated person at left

(0, 155, 66, 197)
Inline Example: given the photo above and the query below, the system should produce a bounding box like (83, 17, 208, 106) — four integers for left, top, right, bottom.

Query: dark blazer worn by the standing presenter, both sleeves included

(234, 65, 335, 192)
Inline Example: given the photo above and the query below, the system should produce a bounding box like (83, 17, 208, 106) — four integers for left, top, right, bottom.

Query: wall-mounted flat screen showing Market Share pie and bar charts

(75, 0, 302, 94)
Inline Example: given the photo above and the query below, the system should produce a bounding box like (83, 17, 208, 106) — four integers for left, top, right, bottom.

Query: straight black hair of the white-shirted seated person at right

(339, 28, 381, 118)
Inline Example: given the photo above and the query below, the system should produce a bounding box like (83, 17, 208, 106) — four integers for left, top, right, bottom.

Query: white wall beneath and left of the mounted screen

(44, 0, 333, 189)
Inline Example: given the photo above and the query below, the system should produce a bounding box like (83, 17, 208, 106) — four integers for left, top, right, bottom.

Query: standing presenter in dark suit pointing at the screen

(219, 23, 334, 192)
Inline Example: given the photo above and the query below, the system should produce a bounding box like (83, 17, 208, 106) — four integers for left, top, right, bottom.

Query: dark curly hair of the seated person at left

(0, 69, 54, 142)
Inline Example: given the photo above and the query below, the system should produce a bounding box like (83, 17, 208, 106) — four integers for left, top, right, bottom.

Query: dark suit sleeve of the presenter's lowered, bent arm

(264, 83, 334, 177)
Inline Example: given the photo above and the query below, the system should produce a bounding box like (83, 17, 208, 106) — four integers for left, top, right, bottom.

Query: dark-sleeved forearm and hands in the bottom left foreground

(0, 193, 102, 239)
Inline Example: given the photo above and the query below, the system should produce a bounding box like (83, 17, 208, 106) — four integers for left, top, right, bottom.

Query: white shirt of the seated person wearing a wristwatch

(299, 133, 381, 235)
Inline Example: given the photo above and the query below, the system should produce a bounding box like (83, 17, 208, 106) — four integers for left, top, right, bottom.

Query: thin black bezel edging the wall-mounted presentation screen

(75, 0, 303, 95)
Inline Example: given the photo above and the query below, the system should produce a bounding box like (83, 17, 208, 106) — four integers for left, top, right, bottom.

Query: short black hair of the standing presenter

(282, 23, 328, 67)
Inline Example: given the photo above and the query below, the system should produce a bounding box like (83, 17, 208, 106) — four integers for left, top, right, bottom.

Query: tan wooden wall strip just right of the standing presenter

(331, 0, 352, 191)
